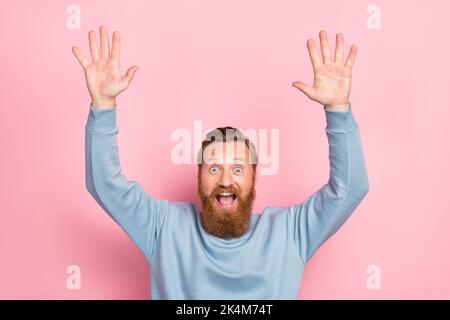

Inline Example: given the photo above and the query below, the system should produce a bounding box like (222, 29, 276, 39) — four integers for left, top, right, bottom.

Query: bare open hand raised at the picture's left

(72, 26, 138, 110)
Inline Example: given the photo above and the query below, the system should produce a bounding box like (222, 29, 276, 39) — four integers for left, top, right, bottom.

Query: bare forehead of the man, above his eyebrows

(203, 141, 250, 164)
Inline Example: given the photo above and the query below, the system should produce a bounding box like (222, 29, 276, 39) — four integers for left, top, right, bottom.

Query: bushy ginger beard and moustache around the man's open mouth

(198, 173, 256, 239)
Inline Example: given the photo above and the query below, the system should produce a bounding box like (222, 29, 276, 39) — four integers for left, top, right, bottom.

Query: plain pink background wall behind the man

(0, 0, 450, 299)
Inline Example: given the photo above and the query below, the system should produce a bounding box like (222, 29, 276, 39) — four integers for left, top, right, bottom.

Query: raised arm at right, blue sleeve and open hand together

(288, 31, 369, 264)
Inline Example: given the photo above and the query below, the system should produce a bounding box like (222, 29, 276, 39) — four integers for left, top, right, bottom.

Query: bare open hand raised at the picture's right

(292, 30, 357, 111)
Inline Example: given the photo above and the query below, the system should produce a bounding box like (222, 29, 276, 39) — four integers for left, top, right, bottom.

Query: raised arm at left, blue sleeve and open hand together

(73, 26, 168, 257)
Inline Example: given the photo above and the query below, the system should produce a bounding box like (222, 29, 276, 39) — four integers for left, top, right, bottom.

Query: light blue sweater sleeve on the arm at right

(288, 104, 369, 264)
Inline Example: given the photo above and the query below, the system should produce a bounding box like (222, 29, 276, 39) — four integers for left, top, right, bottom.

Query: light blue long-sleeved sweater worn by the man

(85, 105, 369, 299)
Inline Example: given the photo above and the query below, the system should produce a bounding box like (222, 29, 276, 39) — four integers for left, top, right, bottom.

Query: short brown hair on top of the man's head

(197, 126, 258, 169)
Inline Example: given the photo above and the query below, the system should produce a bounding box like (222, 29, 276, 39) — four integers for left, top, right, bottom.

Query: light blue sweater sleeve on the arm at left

(85, 104, 168, 257)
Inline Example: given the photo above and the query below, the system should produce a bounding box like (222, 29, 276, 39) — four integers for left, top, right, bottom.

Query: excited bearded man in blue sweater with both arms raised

(72, 26, 369, 299)
